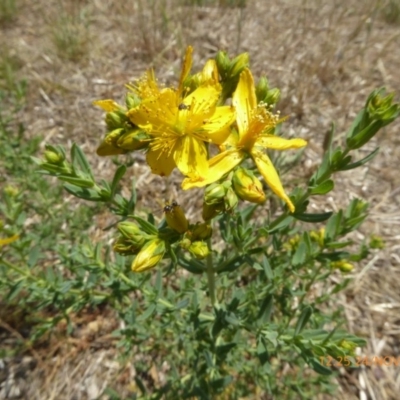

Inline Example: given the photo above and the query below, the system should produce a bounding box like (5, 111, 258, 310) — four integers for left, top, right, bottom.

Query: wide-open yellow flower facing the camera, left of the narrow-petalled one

(127, 47, 235, 177)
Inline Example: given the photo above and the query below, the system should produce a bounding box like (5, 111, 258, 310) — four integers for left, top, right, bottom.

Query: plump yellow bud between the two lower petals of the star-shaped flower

(232, 168, 265, 204)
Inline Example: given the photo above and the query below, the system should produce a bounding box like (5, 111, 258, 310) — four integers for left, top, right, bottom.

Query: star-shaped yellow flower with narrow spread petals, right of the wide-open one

(182, 69, 307, 212)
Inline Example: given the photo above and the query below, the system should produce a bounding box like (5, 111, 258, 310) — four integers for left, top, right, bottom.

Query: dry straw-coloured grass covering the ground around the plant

(0, 0, 400, 400)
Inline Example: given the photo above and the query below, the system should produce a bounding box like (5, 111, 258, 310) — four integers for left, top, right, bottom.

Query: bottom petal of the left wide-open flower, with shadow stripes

(174, 135, 208, 176)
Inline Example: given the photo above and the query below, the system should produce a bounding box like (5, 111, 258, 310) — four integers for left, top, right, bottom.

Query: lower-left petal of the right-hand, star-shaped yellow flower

(182, 149, 245, 190)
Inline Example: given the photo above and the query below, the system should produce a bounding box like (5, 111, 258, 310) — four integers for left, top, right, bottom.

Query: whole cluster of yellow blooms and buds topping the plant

(94, 47, 306, 271)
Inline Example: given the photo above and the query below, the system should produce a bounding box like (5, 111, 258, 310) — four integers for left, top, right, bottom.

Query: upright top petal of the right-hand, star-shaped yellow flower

(232, 69, 257, 141)
